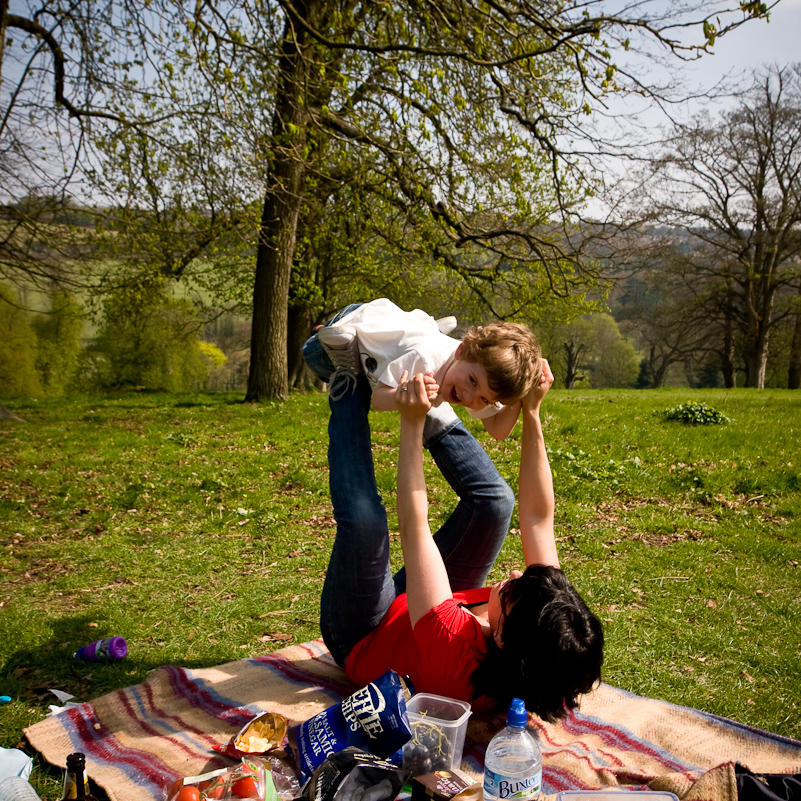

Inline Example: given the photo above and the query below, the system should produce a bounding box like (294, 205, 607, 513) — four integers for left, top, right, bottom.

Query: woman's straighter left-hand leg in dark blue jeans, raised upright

(320, 375, 397, 665)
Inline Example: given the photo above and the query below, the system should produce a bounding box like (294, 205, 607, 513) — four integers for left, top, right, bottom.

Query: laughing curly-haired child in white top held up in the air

(303, 298, 542, 446)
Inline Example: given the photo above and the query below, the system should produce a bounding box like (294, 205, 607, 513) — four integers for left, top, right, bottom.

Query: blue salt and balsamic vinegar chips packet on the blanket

(287, 670, 413, 782)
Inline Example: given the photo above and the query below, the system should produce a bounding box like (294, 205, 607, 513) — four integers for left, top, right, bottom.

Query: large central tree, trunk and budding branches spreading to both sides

(3, 0, 768, 401)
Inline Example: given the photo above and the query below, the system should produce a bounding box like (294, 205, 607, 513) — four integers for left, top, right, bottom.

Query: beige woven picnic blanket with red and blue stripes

(25, 640, 801, 801)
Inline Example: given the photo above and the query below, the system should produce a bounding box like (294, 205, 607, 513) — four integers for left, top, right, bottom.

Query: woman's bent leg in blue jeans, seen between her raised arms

(395, 421, 515, 592)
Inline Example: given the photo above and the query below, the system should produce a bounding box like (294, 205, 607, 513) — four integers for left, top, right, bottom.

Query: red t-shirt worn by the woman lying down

(345, 587, 490, 702)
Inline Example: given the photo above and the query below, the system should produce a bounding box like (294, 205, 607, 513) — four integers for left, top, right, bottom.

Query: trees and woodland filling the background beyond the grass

(0, 0, 801, 401)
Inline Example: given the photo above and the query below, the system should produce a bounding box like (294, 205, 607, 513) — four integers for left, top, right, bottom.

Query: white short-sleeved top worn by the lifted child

(336, 298, 502, 419)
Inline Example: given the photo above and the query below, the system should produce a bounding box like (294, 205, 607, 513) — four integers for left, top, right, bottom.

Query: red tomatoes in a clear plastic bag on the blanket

(165, 758, 278, 801)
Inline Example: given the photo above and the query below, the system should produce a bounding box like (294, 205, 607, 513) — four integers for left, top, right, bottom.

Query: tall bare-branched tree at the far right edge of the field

(632, 65, 801, 388)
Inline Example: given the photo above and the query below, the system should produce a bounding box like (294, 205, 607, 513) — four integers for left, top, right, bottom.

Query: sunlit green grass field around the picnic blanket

(0, 390, 801, 799)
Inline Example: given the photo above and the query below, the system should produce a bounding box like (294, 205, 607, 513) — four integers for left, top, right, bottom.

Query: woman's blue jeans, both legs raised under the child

(320, 375, 515, 666)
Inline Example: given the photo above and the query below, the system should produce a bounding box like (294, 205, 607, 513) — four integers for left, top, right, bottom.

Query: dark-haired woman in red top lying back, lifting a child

(320, 360, 603, 721)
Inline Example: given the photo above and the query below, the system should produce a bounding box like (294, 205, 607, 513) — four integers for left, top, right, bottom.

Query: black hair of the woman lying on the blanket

(472, 565, 604, 723)
